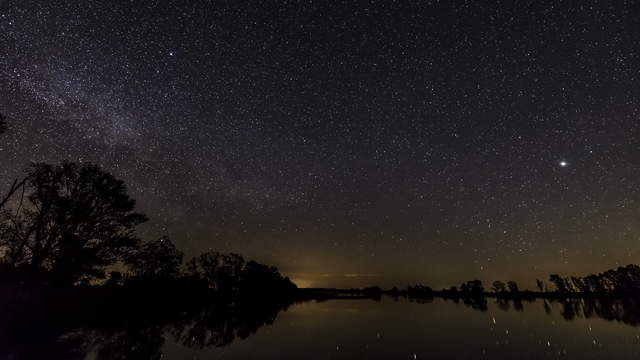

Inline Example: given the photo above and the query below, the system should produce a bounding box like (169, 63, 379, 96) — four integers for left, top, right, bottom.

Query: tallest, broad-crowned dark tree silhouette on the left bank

(0, 162, 146, 285)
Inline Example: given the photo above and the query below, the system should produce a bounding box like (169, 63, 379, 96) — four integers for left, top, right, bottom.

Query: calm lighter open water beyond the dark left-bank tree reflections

(162, 297, 640, 359)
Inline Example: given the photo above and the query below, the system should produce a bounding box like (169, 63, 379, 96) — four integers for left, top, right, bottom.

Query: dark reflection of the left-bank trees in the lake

(0, 302, 290, 360)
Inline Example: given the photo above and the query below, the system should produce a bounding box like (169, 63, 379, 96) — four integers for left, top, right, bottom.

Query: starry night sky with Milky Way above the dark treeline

(0, 0, 640, 287)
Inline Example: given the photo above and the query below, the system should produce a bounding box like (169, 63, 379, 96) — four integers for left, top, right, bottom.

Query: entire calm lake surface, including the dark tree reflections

(0, 297, 640, 360)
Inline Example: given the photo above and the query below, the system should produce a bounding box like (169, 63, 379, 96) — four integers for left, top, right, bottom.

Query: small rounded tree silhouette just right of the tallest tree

(126, 237, 183, 279)
